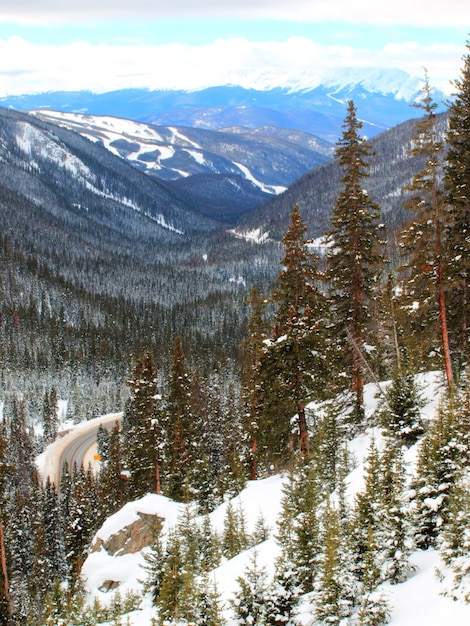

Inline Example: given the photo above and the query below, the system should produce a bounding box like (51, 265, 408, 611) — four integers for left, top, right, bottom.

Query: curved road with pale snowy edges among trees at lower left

(36, 413, 122, 486)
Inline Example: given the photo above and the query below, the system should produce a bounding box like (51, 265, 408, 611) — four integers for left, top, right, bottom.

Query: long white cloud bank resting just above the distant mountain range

(0, 36, 463, 95)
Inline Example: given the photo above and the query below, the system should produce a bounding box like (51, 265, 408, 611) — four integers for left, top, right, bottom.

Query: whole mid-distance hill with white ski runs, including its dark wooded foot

(30, 111, 334, 223)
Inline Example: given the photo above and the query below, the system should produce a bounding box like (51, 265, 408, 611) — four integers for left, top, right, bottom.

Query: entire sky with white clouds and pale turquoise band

(0, 0, 470, 97)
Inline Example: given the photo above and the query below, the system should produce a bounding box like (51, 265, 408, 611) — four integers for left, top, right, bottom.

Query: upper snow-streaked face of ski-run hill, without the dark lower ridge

(33, 111, 334, 200)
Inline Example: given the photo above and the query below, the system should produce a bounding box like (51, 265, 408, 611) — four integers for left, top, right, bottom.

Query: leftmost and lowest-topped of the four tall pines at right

(257, 206, 327, 464)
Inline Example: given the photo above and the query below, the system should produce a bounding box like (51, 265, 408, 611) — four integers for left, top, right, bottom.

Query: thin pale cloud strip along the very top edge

(0, 0, 470, 27)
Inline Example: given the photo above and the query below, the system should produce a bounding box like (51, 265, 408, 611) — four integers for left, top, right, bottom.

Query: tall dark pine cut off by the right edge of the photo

(444, 43, 470, 366)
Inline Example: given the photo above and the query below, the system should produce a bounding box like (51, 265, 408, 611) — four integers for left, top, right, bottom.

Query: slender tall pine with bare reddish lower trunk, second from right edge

(401, 76, 453, 386)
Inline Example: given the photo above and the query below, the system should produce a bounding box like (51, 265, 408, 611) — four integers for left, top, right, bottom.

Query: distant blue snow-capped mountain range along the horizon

(0, 68, 445, 143)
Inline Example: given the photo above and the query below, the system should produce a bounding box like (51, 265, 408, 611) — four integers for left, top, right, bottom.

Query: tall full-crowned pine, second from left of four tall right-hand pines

(327, 101, 385, 424)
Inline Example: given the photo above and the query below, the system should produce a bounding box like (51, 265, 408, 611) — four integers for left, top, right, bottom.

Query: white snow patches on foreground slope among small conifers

(83, 374, 470, 626)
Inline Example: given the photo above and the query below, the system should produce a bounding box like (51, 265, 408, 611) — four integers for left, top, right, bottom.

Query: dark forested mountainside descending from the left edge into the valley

(0, 105, 278, 418)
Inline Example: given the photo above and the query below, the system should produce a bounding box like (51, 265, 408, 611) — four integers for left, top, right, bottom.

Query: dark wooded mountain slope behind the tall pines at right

(236, 113, 448, 240)
